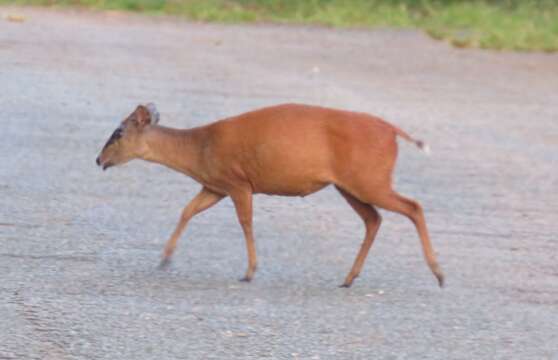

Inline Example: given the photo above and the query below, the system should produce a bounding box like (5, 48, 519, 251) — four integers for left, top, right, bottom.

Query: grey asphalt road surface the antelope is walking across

(0, 7, 558, 359)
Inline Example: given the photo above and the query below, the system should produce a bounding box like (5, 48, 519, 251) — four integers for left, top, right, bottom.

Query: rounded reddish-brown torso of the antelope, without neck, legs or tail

(206, 104, 395, 195)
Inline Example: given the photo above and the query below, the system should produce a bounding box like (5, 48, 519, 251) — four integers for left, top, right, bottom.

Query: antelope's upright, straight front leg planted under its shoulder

(231, 191, 257, 281)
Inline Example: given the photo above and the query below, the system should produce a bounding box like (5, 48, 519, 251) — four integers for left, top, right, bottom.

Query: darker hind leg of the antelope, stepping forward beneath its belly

(336, 186, 382, 287)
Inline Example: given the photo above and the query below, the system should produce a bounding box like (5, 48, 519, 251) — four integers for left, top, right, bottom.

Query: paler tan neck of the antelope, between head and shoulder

(141, 125, 202, 177)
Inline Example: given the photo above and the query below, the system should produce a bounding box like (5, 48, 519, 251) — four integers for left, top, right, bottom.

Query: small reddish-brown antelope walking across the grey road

(97, 104, 444, 287)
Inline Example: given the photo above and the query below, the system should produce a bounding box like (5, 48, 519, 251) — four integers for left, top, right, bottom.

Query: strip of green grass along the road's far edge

(0, 0, 558, 51)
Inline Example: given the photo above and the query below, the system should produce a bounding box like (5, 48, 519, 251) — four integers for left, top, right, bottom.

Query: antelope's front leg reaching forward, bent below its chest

(159, 187, 224, 267)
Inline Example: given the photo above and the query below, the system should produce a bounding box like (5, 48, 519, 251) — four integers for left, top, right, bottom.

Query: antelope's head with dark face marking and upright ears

(97, 104, 159, 170)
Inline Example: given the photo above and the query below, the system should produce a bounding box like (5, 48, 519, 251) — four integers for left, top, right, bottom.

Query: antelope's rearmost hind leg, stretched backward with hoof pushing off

(374, 192, 444, 287)
